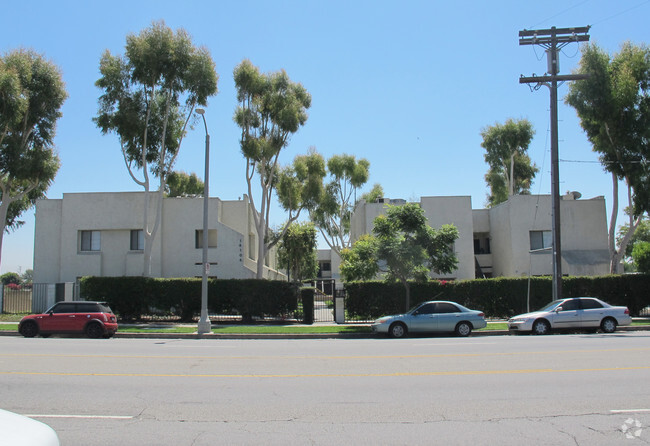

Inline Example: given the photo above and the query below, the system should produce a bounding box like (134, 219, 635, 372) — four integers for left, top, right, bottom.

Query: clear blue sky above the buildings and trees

(0, 0, 650, 273)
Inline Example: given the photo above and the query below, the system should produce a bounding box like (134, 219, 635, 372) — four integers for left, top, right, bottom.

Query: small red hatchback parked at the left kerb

(18, 301, 117, 338)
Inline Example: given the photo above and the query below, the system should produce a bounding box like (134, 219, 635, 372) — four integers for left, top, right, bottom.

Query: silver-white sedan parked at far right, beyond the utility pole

(508, 297, 632, 335)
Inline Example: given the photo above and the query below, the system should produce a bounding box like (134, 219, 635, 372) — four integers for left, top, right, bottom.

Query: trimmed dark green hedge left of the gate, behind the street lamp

(81, 277, 299, 321)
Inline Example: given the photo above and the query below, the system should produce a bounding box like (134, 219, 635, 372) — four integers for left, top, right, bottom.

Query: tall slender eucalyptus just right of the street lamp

(233, 60, 316, 279)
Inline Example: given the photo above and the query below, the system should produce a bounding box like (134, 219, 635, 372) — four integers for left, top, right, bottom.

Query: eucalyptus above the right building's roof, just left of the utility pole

(481, 119, 539, 206)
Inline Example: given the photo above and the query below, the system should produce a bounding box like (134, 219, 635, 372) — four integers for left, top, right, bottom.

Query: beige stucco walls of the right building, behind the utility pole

(344, 195, 608, 279)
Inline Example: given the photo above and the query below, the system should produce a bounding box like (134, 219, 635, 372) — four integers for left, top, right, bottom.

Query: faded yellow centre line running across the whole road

(0, 366, 650, 378)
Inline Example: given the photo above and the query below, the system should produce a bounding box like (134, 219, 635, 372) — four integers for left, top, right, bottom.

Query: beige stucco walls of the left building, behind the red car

(34, 192, 284, 283)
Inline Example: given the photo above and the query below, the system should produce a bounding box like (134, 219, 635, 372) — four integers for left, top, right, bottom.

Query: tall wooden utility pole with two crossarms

(519, 26, 590, 300)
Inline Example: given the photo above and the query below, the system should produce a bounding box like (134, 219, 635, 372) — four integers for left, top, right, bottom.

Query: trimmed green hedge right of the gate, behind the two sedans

(345, 274, 650, 319)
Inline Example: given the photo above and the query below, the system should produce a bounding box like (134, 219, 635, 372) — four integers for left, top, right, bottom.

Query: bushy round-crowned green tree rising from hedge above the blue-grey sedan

(341, 203, 458, 310)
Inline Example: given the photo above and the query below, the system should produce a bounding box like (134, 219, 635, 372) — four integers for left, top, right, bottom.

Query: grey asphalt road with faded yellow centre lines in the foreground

(0, 332, 650, 446)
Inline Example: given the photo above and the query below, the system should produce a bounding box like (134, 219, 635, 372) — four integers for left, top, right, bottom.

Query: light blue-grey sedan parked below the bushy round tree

(370, 301, 487, 338)
